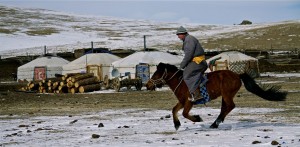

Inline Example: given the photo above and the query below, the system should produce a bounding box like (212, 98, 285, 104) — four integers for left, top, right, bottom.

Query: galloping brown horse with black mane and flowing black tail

(146, 63, 287, 130)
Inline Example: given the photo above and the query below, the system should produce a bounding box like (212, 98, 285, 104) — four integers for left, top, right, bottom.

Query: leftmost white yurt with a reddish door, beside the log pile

(17, 55, 69, 81)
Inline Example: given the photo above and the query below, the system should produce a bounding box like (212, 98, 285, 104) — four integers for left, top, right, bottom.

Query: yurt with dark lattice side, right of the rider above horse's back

(207, 51, 259, 77)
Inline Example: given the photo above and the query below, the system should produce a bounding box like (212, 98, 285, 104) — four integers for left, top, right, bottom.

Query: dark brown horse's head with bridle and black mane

(146, 63, 178, 90)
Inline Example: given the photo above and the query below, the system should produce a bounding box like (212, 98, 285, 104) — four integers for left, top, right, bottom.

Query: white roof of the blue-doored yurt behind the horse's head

(112, 51, 182, 67)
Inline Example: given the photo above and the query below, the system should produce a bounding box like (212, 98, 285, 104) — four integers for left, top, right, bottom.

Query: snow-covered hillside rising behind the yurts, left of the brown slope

(0, 6, 296, 58)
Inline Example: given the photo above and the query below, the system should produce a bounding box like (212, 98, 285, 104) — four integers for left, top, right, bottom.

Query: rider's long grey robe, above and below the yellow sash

(180, 34, 208, 93)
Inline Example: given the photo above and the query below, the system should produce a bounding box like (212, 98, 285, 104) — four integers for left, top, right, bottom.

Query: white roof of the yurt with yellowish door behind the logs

(64, 53, 120, 67)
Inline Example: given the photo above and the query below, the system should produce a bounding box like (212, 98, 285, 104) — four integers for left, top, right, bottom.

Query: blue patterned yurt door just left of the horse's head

(135, 63, 150, 84)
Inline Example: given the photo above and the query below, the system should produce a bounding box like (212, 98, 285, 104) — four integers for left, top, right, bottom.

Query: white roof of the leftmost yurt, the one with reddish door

(19, 56, 69, 68)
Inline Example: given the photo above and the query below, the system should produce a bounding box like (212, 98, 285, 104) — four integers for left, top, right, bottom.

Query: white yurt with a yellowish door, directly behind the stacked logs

(62, 53, 120, 81)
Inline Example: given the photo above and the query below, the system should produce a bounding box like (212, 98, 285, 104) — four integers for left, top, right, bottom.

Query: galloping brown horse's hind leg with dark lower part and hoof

(210, 97, 235, 128)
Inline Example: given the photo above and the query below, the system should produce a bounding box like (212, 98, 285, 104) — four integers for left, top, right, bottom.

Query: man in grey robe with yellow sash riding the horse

(176, 26, 208, 102)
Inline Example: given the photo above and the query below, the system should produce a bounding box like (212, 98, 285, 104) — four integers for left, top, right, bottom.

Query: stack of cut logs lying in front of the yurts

(21, 73, 101, 94)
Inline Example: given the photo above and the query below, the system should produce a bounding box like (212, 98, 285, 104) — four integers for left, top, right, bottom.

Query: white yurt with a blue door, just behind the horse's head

(109, 51, 182, 83)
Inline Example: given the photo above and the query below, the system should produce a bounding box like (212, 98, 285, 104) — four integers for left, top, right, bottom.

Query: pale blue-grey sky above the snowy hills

(0, 0, 300, 25)
